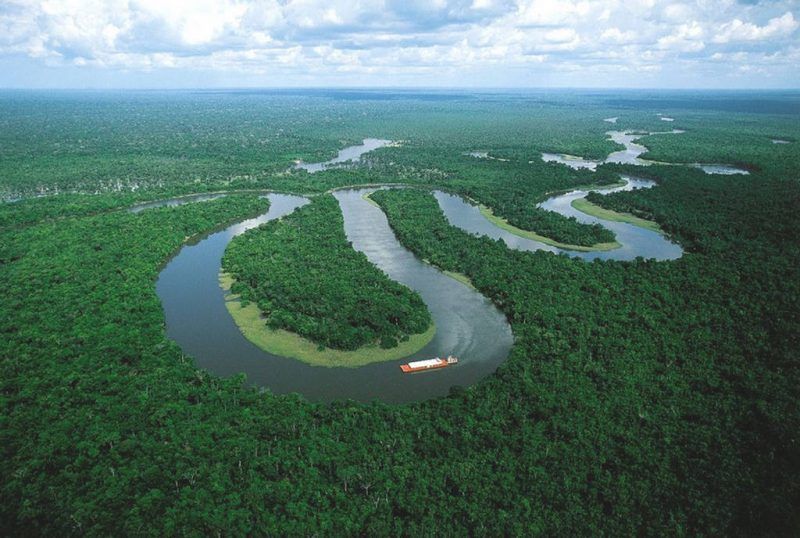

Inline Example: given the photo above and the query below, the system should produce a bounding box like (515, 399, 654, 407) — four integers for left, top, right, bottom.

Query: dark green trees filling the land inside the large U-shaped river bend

(222, 194, 431, 350)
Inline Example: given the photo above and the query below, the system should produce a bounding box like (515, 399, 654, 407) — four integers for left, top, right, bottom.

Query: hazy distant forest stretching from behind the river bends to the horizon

(0, 90, 800, 246)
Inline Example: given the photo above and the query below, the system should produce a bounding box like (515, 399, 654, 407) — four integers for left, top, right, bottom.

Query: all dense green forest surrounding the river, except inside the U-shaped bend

(0, 93, 800, 536)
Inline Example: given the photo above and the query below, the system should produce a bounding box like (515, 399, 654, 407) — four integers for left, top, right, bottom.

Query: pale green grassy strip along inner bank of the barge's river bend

(219, 273, 436, 368)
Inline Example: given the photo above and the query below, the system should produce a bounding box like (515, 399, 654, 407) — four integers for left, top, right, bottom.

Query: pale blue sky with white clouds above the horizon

(0, 0, 800, 89)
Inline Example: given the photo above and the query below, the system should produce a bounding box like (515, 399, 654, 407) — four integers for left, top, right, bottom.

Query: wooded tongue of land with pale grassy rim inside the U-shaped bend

(220, 195, 435, 367)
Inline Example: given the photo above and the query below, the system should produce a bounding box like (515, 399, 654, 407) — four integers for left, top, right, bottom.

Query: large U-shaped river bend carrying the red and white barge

(156, 189, 513, 403)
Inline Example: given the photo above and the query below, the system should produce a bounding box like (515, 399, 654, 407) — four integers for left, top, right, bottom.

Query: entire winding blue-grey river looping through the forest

(152, 131, 682, 403)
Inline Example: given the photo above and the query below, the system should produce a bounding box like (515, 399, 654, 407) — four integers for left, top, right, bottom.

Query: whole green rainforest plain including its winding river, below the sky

(0, 89, 800, 536)
